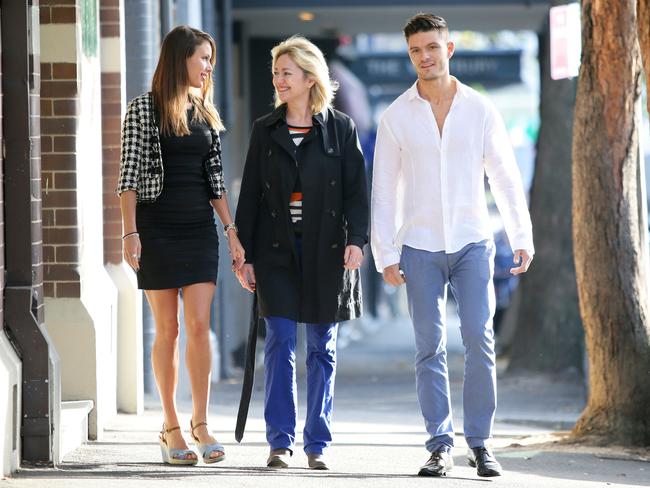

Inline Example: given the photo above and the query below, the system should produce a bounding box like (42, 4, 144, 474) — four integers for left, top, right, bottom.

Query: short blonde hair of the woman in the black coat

(271, 36, 339, 114)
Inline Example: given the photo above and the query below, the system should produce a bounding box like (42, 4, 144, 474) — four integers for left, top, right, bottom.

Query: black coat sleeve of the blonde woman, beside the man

(343, 119, 368, 249)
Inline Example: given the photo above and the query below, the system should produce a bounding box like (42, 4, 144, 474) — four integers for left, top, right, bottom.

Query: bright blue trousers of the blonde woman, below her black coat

(264, 317, 338, 454)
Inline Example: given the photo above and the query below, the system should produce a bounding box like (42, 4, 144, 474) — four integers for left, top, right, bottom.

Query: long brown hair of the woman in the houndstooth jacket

(151, 25, 224, 136)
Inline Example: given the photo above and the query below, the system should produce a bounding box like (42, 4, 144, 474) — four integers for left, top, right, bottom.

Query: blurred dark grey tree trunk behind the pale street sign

(506, 1, 584, 373)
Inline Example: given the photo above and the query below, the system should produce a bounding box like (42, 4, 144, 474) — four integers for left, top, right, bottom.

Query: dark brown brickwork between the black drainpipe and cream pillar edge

(40, 0, 80, 298)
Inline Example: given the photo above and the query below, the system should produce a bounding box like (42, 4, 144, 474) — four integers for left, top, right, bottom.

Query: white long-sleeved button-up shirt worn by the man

(371, 78, 534, 272)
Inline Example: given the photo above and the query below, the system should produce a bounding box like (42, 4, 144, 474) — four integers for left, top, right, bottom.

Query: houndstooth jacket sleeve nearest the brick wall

(116, 99, 143, 195)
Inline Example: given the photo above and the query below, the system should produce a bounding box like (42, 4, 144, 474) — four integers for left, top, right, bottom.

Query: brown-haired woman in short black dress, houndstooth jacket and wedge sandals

(118, 26, 244, 464)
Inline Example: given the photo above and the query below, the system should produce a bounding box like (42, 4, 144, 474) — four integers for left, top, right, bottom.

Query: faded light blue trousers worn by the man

(400, 240, 496, 451)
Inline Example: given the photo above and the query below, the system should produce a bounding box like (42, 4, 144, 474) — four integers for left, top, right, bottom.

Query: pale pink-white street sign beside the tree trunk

(549, 3, 581, 80)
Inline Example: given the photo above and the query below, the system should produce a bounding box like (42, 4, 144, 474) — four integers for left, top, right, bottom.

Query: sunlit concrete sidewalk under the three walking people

(6, 314, 650, 488)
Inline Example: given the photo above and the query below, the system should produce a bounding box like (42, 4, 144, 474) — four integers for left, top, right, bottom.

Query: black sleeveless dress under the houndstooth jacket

(136, 109, 219, 290)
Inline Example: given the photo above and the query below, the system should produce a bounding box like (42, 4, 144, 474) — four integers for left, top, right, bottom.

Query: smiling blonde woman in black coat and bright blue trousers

(235, 36, 368, 469)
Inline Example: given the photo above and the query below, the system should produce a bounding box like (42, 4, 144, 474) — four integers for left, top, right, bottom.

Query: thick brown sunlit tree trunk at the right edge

(573, 0, 650, 446)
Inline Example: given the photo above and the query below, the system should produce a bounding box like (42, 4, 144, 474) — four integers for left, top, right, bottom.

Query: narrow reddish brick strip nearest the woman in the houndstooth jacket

(99, 0, 124, 264)
